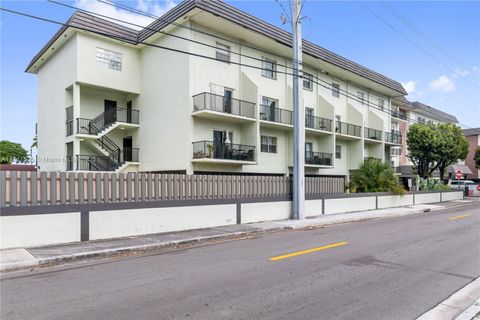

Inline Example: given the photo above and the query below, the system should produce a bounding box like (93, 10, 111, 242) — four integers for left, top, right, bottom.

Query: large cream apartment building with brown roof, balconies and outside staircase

(27, 0, 406, 180)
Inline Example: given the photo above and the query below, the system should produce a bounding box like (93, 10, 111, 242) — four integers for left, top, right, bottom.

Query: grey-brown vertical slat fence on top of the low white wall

(0, 171, 345, 207)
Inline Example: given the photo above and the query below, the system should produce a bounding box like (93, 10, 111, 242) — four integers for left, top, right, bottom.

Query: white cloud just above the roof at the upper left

(75, 0, 176, 30)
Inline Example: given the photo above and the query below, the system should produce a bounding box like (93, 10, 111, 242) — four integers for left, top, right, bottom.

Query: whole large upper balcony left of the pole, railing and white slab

(192, 92, 255, 122)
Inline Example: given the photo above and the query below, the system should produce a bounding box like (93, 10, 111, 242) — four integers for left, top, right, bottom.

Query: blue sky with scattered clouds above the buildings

(0, 0, 480, 149)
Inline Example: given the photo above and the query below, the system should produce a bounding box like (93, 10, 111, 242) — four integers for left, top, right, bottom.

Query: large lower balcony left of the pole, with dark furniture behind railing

(192, 140, 255, 164)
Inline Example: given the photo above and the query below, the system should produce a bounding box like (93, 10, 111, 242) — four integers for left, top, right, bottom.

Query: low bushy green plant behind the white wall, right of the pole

(348, 158, 405, 195)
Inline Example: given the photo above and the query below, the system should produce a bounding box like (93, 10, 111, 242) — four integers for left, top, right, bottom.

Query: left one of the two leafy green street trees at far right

(407, 124, 441, 178)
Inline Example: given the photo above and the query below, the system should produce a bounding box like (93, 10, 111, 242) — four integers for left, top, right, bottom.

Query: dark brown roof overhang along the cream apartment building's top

(26, 0, 407, 96)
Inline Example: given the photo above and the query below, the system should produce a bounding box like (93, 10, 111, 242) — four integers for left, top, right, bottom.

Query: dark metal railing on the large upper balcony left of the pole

(193, 92, 255, 119)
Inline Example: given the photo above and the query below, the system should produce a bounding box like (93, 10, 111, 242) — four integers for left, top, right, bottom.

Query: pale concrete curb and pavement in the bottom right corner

(416, 278, 480, 320)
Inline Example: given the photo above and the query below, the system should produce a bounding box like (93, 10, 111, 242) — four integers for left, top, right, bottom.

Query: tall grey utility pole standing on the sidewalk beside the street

(292, 0, 305, 220)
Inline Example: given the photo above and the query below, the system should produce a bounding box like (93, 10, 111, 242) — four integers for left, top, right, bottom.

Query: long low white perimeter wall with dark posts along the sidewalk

(0, 191, 463, 249)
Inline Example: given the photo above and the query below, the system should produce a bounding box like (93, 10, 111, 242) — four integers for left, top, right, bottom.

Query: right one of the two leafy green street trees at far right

(436, 123, 468, 181)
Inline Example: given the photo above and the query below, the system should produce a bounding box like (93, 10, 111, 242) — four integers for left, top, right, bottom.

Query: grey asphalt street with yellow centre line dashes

(0, 204, 480, 320)
